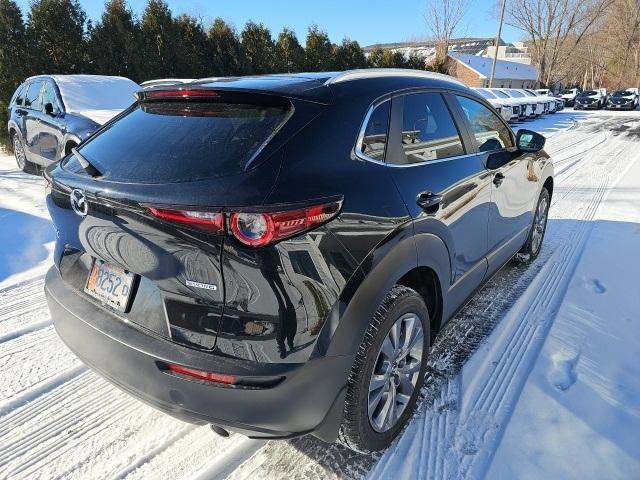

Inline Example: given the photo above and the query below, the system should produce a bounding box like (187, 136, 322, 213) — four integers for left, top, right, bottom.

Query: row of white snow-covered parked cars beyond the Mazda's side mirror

(475, 88, 564, 122)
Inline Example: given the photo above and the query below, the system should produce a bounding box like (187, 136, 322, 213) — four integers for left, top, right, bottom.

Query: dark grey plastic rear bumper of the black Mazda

(45, 267, 353, 441)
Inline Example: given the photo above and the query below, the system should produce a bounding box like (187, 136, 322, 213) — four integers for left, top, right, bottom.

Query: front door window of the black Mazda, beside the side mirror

(456, 95, 513, 152)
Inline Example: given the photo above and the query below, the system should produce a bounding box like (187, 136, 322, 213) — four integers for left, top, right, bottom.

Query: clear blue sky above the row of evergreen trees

(18, 0, 521, 46)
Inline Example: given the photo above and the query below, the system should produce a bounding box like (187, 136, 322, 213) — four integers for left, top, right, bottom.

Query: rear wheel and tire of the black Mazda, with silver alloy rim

(338, 285, 431, 453)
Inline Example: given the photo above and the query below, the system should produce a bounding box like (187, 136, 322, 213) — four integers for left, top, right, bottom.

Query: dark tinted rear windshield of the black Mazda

(65, 102, 288, 183)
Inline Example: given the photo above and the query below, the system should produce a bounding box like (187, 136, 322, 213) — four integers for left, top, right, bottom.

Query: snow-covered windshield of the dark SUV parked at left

(54, 75, 142, 113)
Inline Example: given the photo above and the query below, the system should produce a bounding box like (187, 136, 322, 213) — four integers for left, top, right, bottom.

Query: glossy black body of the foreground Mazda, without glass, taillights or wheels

(45, 74, 553, 441)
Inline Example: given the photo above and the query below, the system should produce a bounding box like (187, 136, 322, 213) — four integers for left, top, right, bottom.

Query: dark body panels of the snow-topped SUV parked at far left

(7, 76, 106, 167)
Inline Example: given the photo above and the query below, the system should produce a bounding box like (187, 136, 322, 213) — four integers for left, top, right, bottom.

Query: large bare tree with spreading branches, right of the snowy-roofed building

(505, 0, 615, 85)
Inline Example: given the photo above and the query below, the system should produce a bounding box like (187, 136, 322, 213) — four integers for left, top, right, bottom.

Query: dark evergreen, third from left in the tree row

(88, 0, 141, 81)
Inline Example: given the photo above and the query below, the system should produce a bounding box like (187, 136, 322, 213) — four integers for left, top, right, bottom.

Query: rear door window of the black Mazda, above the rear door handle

(394, 93, 465, 164)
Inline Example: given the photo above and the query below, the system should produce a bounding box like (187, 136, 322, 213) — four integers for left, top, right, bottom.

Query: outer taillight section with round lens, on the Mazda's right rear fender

(229, 202, 341, 247)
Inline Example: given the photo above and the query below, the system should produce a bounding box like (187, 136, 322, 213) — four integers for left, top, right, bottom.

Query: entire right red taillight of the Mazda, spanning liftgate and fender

(149, 201, 342, 247)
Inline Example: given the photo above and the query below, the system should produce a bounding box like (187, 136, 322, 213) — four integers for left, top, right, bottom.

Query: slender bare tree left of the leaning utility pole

(424, 0, 468, 64)
